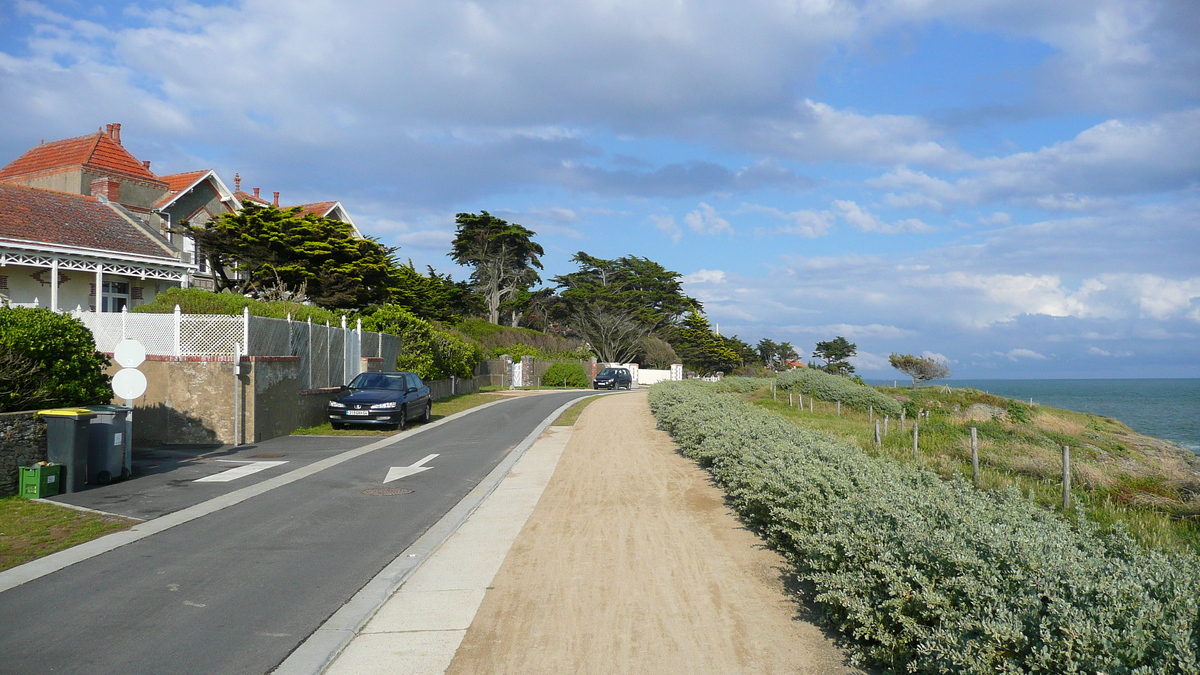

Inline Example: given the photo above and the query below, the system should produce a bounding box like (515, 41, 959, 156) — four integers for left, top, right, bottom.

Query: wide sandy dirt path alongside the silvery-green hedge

(448, 393, 858, 675)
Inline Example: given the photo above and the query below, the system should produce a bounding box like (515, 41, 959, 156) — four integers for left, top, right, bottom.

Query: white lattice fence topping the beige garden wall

(71, 306, 400, 389)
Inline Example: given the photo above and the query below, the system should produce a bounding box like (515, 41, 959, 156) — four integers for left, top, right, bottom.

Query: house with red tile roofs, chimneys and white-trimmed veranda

(0, 124, 248, 311)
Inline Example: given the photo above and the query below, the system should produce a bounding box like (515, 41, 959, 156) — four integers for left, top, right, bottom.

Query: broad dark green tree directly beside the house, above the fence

(176, 203, 396, 309)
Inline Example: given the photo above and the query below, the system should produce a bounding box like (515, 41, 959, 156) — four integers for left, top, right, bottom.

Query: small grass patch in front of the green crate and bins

(0, 496, 137, 571)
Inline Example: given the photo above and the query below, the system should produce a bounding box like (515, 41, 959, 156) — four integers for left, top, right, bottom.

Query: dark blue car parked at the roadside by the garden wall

(329, 372, 433, 429)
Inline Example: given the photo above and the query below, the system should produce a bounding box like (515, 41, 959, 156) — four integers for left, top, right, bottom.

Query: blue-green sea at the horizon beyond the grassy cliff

(872, 378, 1200, 454)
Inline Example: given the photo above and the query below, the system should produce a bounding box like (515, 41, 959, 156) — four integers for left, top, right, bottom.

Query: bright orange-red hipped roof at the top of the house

(0, 132, 166, 187)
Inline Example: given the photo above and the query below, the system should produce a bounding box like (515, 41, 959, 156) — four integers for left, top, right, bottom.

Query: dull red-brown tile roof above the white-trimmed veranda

(0, 183, 175, 262)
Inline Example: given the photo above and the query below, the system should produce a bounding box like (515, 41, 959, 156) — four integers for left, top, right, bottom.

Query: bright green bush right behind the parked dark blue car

(362, 305, 482, 380)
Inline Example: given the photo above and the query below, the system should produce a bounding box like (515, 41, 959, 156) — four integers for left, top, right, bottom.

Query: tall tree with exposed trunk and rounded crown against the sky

(450, 211, 546, 324)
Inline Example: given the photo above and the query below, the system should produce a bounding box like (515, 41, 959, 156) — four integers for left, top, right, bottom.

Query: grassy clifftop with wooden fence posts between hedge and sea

(746, 387, 1200, 552)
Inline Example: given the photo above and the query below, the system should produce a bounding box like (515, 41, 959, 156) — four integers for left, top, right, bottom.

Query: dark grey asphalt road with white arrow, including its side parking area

(0, 392, 590, 674)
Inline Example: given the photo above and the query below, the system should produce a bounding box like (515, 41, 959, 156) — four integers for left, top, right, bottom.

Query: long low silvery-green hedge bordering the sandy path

(650, 382, 1200, 675)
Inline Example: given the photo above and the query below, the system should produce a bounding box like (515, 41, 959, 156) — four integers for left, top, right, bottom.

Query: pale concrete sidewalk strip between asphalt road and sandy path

(316, 426, 572, 675)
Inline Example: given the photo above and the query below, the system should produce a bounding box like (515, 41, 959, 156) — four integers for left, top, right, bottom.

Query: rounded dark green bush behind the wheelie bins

(0, 307, 113, 412)
